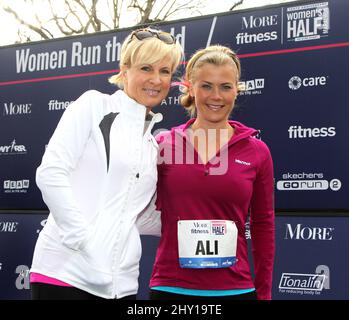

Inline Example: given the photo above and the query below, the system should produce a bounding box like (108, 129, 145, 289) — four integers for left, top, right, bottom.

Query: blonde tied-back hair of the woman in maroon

(180, 45, 241, 117)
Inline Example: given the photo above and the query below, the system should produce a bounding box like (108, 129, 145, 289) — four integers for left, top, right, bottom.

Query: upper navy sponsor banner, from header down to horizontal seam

(0, 0, 349, 210)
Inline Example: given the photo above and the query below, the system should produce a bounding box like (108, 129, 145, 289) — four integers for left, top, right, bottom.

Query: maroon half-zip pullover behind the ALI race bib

(150, 119, 275, 299)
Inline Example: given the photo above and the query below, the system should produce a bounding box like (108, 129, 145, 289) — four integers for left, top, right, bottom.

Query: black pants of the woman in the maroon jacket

(150, 289, 257, 300)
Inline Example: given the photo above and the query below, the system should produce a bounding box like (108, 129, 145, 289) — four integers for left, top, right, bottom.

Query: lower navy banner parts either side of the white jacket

(0, 212, 159, 300)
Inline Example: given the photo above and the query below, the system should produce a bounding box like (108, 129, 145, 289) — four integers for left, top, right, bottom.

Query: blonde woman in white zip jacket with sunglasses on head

(30, 28, 182, 300)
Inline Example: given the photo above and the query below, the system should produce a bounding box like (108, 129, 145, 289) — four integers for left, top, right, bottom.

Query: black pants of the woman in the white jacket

(30, 282, 136, 300)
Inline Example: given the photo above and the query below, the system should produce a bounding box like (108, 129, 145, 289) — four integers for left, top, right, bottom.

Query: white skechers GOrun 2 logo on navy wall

(276, 172, 342, 191)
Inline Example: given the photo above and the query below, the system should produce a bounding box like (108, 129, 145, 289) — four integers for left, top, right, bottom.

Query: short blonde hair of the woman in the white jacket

(109, 28, 183, 89)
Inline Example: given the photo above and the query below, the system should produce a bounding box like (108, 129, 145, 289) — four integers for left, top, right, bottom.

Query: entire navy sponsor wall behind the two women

(0, 0, 349, 299)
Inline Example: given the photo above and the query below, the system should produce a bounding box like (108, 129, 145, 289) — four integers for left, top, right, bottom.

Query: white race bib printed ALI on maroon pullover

(178, 220, 238, 269)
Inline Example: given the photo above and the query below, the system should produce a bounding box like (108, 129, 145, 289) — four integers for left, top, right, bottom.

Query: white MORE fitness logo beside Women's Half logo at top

(235, 15, 278, 44)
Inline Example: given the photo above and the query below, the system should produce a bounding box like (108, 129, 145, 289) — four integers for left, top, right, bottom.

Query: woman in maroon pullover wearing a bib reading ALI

(150, 46, 274, 299)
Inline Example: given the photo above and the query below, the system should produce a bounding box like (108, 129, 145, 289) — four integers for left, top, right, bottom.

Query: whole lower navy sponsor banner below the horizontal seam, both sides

(0, 214, 349, 300)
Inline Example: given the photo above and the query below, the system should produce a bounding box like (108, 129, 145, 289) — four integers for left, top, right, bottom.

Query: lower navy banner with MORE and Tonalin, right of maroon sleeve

(273, 213, 349, 300)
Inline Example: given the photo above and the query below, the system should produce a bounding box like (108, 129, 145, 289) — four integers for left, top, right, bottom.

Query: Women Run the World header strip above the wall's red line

(0, 0, 348, 82)
